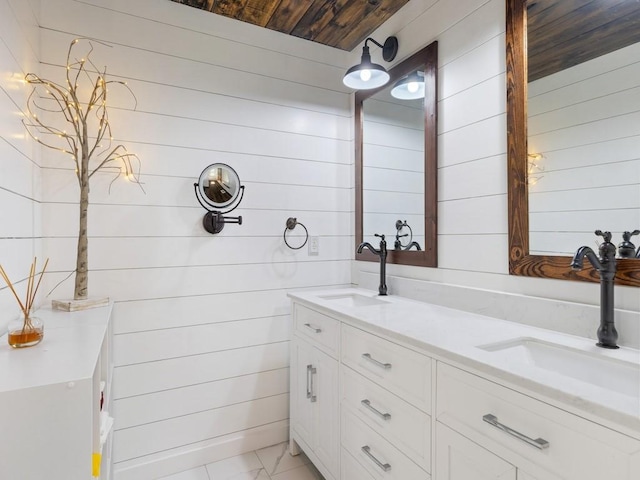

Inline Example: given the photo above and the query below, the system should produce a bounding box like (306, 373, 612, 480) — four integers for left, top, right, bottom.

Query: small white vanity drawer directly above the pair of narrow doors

(293, 303, 340, 357)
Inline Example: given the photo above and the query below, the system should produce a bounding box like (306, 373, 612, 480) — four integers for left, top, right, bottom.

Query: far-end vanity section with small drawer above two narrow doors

(290, 304, 340, 480)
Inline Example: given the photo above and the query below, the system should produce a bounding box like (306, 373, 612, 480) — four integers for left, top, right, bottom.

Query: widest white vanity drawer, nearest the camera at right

(436, 362, 640, 480)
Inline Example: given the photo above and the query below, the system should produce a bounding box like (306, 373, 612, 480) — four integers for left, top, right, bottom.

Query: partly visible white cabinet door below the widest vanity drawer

(435, 422, 516, 480)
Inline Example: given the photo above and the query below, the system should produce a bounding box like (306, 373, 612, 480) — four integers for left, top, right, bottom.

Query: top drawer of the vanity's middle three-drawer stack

(342, 324, 431, 413)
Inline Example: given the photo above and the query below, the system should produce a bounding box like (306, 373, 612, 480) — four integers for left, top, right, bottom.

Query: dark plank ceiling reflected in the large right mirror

(527, 0, 640, 82)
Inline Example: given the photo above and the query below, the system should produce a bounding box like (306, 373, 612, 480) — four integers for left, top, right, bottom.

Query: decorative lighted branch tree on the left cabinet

(23, 39, 144, 300)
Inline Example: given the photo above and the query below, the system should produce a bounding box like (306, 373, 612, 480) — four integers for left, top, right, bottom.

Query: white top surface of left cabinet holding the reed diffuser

(0, 304, 112, 392)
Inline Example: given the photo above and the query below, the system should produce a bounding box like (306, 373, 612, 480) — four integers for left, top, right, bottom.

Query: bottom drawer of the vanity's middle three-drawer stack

(342, 409, 431, 480)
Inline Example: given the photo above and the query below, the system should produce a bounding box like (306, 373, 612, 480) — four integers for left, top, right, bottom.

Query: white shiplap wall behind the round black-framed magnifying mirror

(33, 0, 353, 480)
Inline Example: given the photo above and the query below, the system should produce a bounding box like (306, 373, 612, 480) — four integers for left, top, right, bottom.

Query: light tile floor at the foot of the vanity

(159, 443, 324, 480)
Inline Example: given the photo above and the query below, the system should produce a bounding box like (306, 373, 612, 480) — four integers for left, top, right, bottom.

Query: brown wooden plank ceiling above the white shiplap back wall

(171, 0, 409, 52)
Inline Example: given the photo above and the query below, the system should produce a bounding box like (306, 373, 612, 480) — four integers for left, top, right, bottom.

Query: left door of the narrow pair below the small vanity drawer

(290, 337, 314, 445)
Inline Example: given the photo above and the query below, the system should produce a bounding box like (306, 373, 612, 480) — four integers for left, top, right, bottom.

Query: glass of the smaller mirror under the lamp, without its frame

(362, 71, 424, 250)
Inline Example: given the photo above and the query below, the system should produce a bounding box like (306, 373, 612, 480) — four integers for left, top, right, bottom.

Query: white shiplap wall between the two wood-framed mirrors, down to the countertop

(353, 0, 640, 334)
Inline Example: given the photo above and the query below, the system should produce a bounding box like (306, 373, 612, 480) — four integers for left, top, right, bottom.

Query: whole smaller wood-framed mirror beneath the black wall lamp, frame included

(355, 42, 438, 267)
